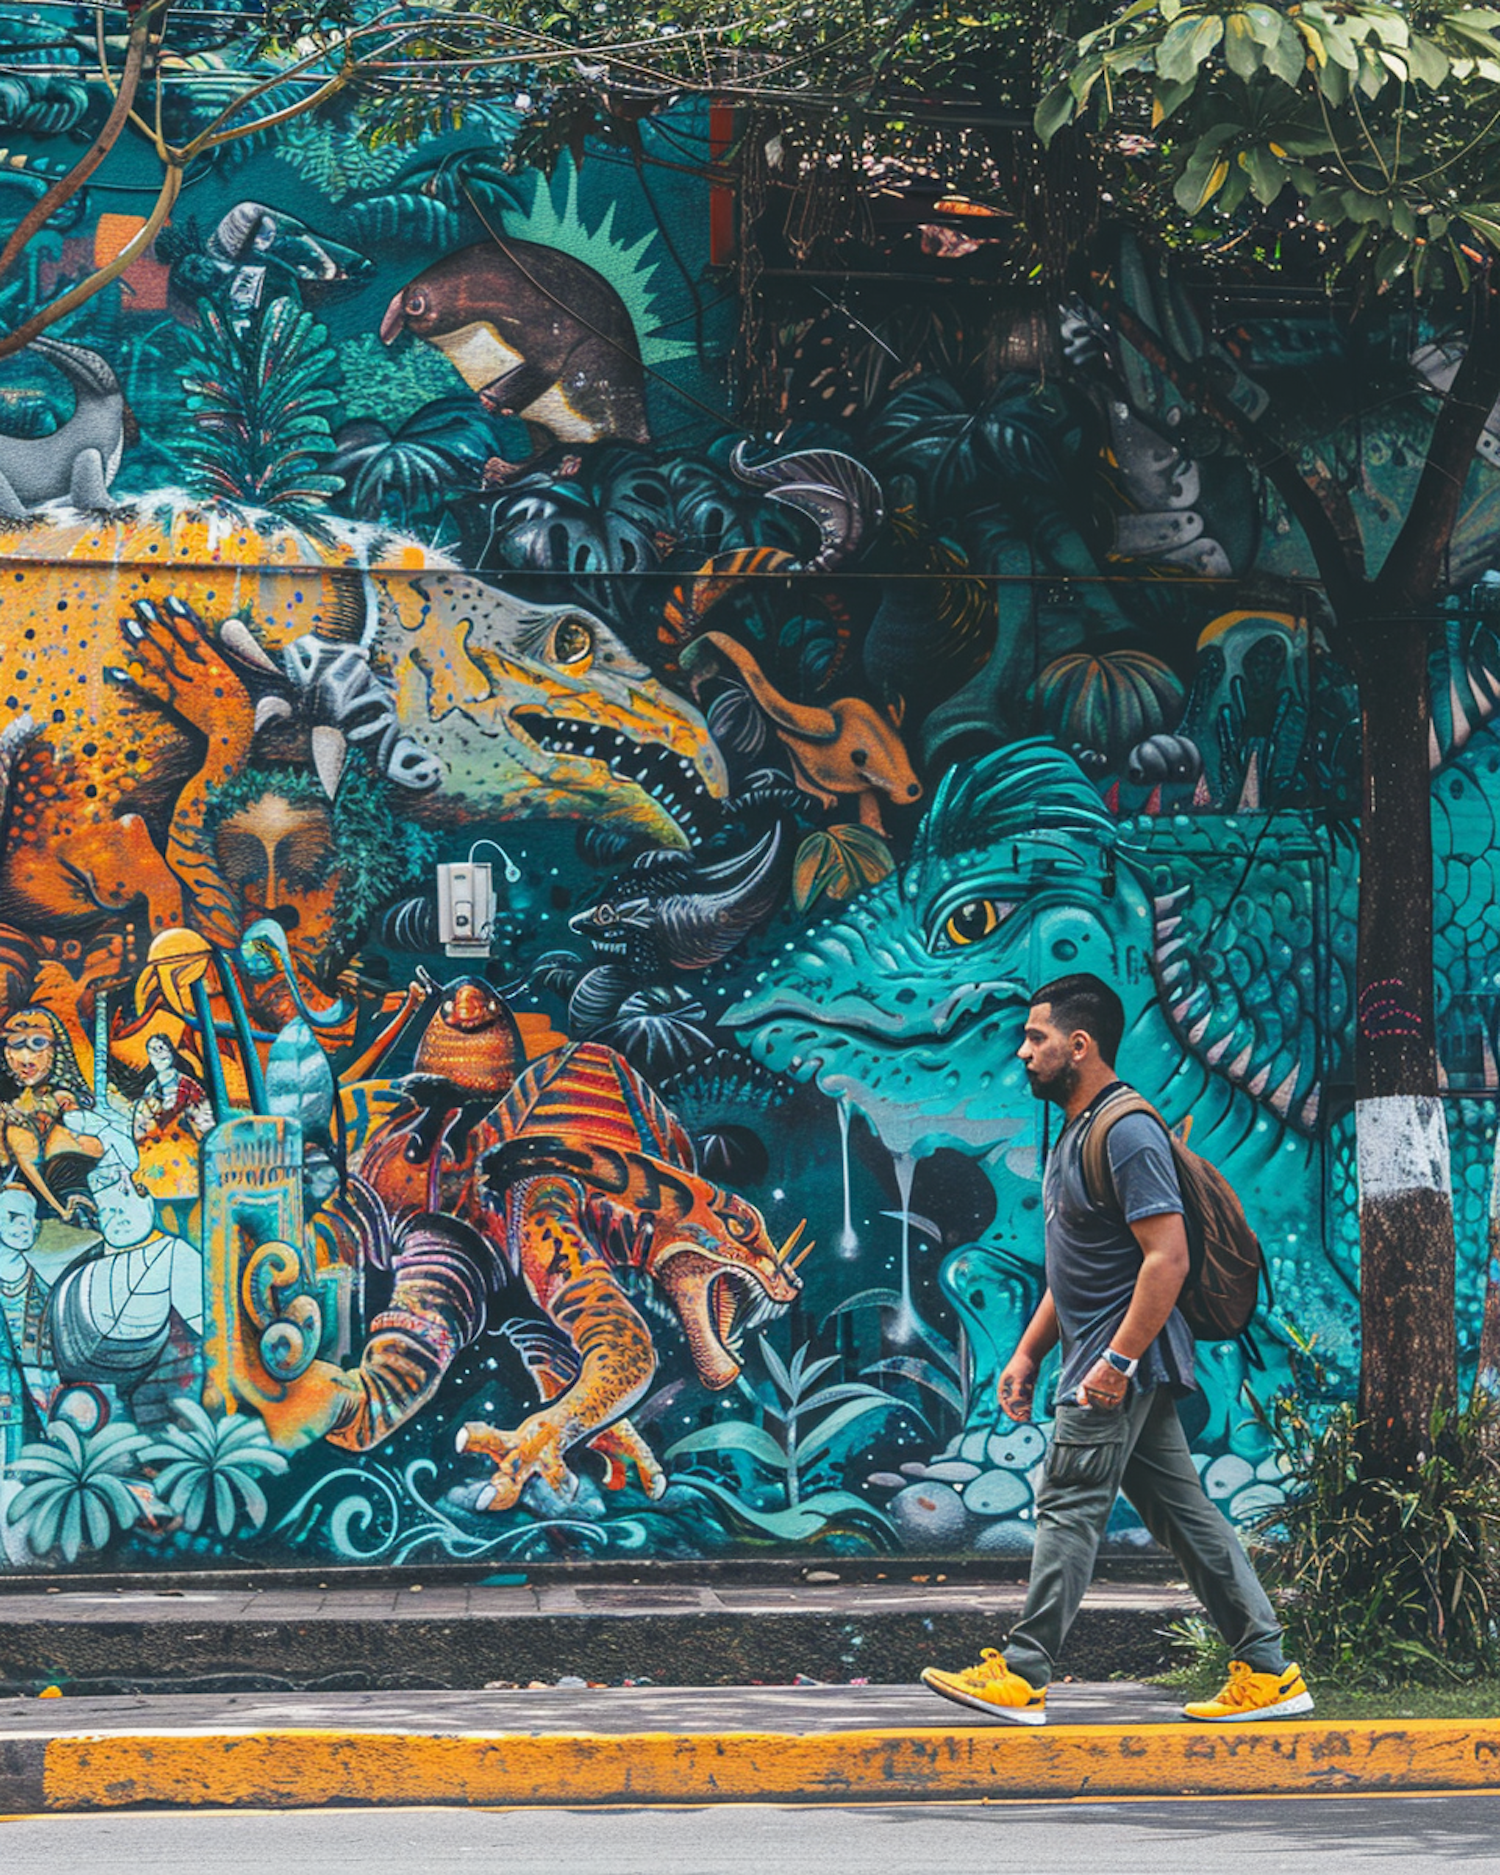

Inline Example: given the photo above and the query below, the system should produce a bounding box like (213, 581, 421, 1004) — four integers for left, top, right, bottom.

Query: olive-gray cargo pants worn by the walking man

(1005, 1386, 1286, 1686)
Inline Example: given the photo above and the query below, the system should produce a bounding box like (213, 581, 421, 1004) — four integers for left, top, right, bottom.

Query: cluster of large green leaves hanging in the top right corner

(1035, 0, 1500, 291)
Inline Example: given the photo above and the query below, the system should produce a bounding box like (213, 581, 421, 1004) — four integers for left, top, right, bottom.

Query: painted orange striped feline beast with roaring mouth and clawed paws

(273, 1043, 803, 1509)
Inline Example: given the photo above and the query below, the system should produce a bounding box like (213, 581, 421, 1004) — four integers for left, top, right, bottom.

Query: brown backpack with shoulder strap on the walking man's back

(1080, 1082, 1269, 1358)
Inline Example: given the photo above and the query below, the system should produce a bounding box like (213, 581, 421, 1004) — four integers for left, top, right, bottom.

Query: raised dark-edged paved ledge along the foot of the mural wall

(0, 1568, 1194, 1695)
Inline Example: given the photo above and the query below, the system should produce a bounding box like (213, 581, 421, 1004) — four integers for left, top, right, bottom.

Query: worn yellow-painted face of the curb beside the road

(26, 1719, 1500, 1811)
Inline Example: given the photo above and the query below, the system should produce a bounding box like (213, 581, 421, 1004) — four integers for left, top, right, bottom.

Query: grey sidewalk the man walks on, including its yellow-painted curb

(0, 1682, 1500, 1815)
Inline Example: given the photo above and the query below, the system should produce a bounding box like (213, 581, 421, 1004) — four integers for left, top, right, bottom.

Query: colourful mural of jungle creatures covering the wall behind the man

(0, 13, 1500, 1569)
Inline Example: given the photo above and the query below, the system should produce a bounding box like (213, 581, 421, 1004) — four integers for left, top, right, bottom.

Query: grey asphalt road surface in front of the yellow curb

(0, 1793, 1500, 1875)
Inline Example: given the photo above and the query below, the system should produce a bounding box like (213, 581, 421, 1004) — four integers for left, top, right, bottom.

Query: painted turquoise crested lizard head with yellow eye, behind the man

(724, 743, 1155, 1155)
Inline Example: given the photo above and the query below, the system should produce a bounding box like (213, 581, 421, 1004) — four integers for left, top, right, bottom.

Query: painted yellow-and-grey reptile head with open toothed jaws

(377, 572, 728, 848)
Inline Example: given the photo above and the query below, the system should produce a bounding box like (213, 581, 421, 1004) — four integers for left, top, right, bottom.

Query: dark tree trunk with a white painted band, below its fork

(1348, 615, 1459, 1474)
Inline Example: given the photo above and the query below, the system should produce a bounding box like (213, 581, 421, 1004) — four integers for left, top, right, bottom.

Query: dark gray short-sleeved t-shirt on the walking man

(1043, 1114, 1196, 1401)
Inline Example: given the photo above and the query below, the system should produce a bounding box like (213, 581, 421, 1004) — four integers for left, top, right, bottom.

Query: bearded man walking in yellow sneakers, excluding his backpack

(923, 975, 1313, 1725)
